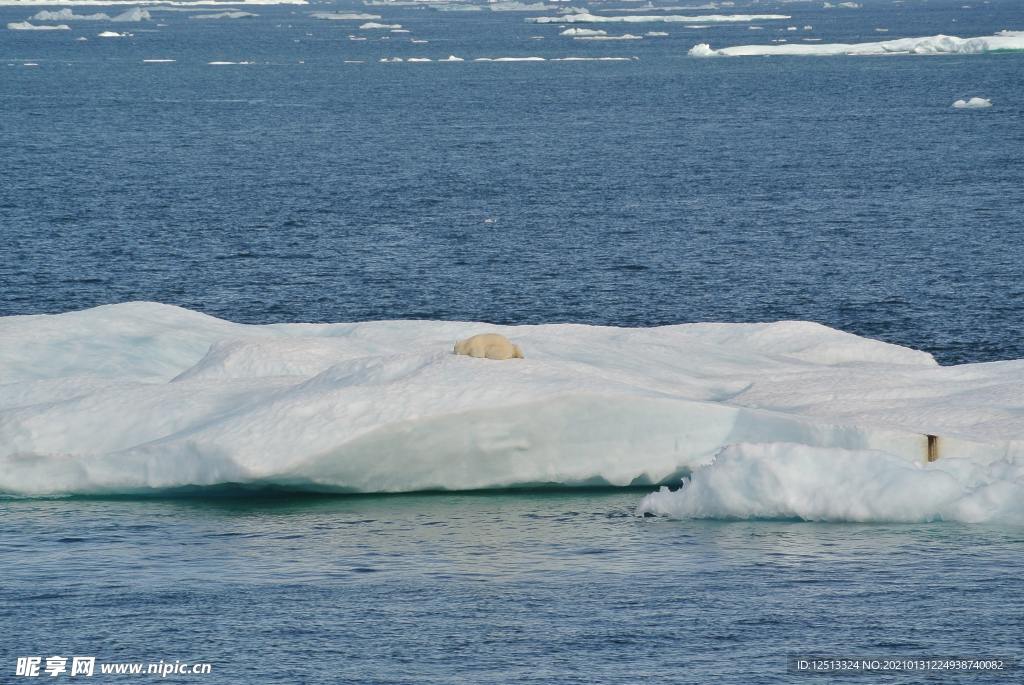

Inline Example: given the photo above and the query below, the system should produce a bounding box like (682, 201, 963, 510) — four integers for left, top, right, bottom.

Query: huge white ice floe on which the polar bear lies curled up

(0, 303, 1024, 520)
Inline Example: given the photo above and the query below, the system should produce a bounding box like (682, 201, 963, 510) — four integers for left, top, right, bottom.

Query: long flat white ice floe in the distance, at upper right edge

(689, 32, 1024, 57)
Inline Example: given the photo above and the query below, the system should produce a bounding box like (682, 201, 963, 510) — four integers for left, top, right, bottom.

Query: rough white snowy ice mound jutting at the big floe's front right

(638, 443, 1024, 525)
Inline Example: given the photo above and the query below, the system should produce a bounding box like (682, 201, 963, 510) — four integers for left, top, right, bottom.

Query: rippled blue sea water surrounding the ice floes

(0, 0, 1024, 684)
